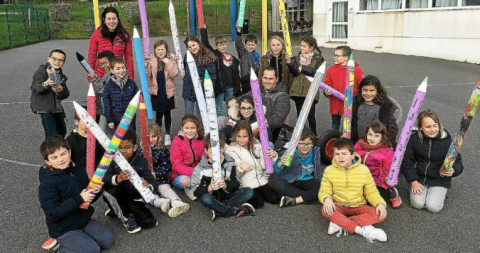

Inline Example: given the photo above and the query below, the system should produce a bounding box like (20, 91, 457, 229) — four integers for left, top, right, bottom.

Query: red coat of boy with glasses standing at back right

(323, 62, 363, 115)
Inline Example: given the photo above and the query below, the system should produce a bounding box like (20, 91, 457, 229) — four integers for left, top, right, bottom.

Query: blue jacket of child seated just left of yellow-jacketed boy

(273, 146, 322, 183)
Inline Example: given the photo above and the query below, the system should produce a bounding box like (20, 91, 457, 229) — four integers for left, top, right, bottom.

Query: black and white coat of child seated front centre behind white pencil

(190, 154, 240, 201)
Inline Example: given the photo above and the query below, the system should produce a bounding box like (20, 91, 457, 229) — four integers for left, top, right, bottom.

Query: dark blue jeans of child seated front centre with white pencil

(200, 187, 253, 217)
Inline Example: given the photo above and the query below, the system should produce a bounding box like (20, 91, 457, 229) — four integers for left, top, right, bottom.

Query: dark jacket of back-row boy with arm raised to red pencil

(200, 28, 241, 96)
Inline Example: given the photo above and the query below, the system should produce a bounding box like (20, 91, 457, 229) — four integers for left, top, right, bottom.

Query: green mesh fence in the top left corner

(0, 5, 51, 50)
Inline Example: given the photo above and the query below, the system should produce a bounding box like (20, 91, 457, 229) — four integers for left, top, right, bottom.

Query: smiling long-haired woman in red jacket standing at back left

(88, 7, 135, 80)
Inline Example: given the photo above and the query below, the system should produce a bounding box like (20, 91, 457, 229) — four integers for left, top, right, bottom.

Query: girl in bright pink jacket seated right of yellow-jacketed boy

(354, 121, 402, 208)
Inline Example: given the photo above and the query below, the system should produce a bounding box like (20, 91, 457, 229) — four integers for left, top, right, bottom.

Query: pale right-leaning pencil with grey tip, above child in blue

(285, 61, 327, 167)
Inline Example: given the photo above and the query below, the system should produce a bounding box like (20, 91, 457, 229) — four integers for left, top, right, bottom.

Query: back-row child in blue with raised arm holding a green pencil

(233, 27, 260, 95)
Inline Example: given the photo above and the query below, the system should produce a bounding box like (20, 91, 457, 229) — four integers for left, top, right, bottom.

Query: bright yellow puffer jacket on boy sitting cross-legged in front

(318, 155, 387, 207)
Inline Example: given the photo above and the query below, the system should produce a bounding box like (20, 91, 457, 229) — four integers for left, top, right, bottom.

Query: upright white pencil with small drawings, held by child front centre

(203, 70, 222, 181)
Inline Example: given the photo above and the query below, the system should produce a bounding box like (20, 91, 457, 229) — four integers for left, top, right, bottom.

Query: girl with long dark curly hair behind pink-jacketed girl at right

(351, 75, 398, 145)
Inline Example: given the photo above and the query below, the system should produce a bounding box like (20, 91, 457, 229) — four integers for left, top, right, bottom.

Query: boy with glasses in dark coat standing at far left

(30, 49, 70, 138)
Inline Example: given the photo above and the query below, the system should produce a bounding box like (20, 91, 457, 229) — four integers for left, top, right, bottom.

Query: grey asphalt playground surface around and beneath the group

(0, 37, 480, 253)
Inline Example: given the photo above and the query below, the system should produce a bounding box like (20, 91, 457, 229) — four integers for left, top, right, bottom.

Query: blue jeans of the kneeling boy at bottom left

(57, 219, 115, 253)
